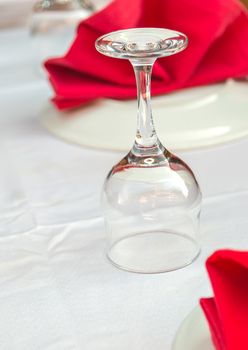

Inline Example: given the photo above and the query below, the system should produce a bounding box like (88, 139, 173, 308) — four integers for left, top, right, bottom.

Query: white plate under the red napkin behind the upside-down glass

(42, 80, 248, 151)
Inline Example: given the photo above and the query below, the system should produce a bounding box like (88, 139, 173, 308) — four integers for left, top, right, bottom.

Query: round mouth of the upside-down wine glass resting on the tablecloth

(107, 231, 200, 273)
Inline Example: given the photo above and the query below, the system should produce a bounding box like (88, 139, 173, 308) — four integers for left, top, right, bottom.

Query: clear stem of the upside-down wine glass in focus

(133, 62, 160, 152)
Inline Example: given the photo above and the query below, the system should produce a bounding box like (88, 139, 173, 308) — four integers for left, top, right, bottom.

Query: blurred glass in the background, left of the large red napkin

(30, 0, 94, 72)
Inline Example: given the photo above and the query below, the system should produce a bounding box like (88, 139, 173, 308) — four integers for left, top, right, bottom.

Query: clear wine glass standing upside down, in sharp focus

(96, 28, 202, 273)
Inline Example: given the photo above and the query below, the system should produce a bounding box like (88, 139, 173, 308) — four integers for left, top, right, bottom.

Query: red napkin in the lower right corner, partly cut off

(200, 250, 248, 350)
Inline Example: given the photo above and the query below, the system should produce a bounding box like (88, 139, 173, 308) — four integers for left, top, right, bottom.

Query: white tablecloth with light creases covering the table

(0, 27, 248, 350)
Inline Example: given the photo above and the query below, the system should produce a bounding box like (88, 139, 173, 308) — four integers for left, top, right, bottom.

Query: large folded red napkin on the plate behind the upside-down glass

(45, 0, 248, 109)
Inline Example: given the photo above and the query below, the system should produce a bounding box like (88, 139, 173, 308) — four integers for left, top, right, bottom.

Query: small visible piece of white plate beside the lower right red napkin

(172, 306, 214, 350)
